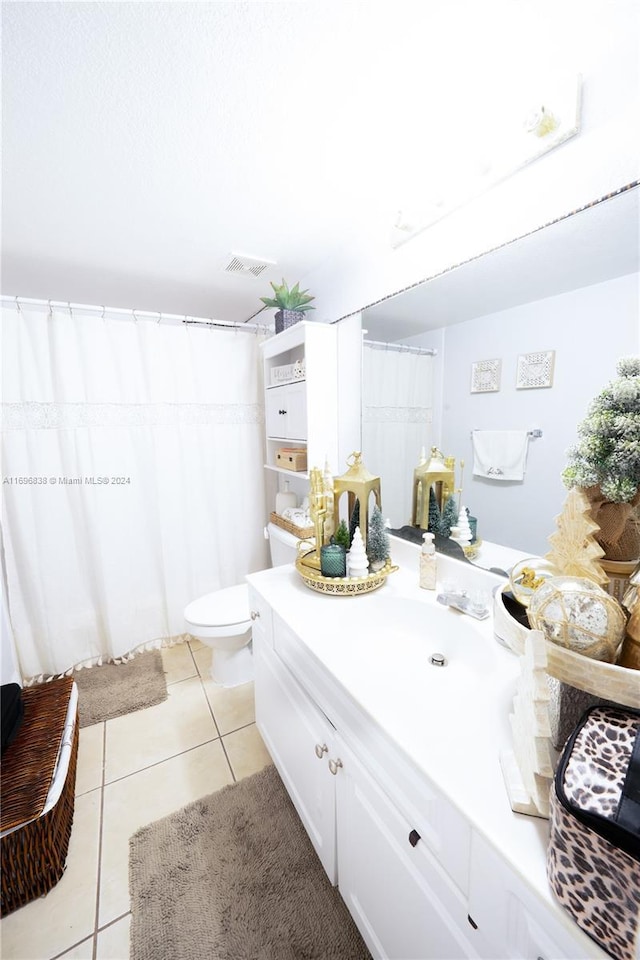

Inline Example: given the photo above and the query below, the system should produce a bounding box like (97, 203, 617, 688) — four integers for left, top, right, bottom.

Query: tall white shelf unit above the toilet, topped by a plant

(262, 320, 342, 478)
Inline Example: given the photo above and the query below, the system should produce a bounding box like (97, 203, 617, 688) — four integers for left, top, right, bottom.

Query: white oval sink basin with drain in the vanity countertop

(318, 593, 510, 736)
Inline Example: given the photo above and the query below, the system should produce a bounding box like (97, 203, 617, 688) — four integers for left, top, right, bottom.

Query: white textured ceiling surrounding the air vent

(2, 0, 640, 320)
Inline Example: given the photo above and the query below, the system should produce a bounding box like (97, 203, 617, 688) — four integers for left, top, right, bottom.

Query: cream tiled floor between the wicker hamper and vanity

(0, 640, 271, 960)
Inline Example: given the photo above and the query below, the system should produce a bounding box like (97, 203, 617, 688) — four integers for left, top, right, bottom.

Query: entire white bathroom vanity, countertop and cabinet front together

(249, 551, 608, 960)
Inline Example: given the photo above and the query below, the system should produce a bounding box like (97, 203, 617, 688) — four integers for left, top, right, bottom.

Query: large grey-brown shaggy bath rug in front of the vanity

(129, 766, 370, 960)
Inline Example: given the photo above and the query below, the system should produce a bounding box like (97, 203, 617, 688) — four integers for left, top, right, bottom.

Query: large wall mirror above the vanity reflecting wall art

(362, 186, 640, 566)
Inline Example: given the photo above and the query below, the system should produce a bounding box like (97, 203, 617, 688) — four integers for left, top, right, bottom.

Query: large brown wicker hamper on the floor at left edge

(0, 677, 79, 917)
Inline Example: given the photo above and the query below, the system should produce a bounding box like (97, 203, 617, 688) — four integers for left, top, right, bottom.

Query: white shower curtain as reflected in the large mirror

(362, 341, 433, 527)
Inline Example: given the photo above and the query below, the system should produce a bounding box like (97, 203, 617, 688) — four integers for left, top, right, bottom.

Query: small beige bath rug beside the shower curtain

(73, 650, 167, 727)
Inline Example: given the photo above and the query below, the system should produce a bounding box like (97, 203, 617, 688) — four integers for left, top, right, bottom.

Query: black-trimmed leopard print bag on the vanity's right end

(547, 706, 640, 960)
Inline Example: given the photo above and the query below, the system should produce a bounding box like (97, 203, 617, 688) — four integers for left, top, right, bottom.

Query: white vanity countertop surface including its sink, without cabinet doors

(248, 538, 605, 956)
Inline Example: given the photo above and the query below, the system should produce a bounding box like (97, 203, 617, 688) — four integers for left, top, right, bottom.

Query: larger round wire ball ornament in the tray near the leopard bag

(527, 577, 626, 663)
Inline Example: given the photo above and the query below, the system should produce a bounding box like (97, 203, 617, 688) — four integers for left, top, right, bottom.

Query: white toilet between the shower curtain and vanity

(184, 523, 298, 687)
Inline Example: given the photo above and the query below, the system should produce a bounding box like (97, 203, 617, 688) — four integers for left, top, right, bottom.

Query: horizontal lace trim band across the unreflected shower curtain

(2, 401, 264, 430)
